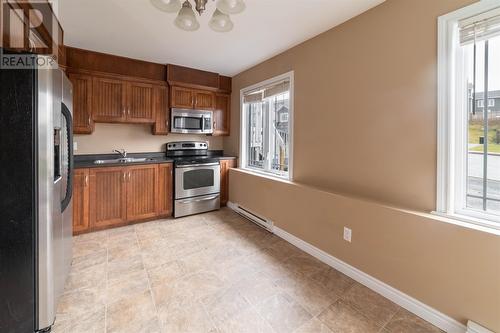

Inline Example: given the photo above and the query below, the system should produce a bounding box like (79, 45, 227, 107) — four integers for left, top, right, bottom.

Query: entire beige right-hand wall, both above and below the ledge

(224, 0, 500, 332)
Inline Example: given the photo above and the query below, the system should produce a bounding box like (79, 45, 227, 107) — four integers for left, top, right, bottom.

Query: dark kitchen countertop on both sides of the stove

(75, 150, 236, 169)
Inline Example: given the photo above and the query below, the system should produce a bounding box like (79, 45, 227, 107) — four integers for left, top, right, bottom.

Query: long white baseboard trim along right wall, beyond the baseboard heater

(274, 226, 468, 333)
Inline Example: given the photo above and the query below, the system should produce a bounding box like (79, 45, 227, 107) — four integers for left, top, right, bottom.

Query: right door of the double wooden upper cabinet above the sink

(127, 82, 155, 123)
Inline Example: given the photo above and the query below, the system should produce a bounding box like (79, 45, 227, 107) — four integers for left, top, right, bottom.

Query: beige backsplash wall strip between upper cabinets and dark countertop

(75, 124, 222, 155)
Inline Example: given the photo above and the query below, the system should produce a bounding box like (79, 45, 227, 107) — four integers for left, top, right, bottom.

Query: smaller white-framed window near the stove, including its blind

(240, 72, 293, 179)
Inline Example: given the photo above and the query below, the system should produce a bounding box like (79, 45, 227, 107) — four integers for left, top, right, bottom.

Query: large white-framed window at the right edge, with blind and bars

(437, 3, 500, 229)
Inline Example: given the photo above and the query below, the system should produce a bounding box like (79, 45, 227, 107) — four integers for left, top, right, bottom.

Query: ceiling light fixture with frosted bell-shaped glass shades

(150, 0, 246, 32)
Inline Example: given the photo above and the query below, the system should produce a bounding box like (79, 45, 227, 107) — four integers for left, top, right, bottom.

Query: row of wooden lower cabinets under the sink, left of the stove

(73, 163, 173, 235)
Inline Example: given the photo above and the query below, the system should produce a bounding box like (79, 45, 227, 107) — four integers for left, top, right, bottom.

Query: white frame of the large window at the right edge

(433, 0, 500, 233)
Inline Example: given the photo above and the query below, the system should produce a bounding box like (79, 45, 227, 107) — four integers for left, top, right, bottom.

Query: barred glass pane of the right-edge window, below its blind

(463, 36, 500, 215)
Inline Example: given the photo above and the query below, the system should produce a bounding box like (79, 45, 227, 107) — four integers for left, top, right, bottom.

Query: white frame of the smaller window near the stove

(240, 71, 294, 181)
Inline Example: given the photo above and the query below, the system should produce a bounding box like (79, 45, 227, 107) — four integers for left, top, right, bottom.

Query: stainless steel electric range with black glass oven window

(167, 141, 220, 217)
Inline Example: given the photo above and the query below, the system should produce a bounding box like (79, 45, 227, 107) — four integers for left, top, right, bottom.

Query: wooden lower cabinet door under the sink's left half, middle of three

(90, 167, 127, 230)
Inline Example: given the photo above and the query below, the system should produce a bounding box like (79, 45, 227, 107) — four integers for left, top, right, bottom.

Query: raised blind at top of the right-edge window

(459, 8, 500, 45)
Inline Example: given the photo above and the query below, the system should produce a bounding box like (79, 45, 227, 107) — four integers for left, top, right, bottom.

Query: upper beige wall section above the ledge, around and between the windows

(224, 0, 474, 211)
